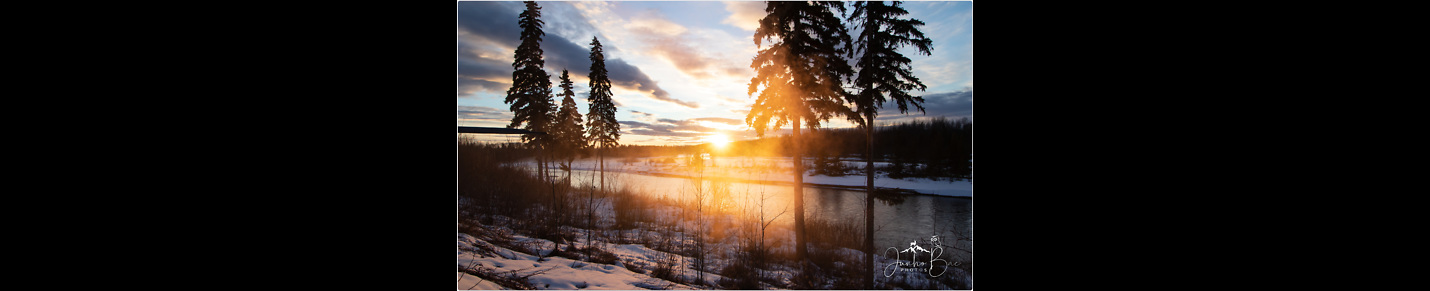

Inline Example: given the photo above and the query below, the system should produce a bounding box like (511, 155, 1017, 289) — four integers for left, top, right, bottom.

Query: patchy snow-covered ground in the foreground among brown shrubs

(456, 210, 972, 290)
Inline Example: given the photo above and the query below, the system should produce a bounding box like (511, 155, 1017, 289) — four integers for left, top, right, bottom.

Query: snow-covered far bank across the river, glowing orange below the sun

(528, 156, 974, 198)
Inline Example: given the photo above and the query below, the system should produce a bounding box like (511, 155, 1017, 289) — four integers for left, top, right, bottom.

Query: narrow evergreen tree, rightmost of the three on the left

(586, 37, 621, 191)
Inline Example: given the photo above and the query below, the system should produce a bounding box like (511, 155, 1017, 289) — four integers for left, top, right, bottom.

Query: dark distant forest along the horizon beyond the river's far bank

(466, 118, 974, 179)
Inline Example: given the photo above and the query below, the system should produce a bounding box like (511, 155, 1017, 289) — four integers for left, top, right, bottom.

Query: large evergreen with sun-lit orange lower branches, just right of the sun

(745, 1, 861, 283)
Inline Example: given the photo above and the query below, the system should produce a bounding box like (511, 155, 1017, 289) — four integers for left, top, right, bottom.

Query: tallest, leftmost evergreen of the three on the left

(505, 1, 556, 179)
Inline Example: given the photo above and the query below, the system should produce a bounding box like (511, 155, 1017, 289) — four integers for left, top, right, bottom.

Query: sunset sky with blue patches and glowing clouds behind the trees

(456, 1, 974, 145)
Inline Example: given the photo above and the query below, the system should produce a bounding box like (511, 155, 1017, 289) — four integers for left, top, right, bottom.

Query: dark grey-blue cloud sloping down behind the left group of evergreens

(456, 1, 699, 108)
